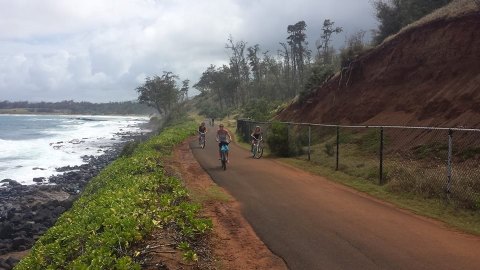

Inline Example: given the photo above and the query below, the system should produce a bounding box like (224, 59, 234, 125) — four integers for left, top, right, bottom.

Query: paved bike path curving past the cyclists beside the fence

(190, 127, 480, 270)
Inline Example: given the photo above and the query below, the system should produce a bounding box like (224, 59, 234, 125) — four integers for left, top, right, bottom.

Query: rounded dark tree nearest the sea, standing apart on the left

(136, 71, 180, 115)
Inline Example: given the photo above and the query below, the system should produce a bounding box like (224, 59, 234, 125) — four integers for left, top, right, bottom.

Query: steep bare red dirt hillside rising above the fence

(278, 0, 480, 128)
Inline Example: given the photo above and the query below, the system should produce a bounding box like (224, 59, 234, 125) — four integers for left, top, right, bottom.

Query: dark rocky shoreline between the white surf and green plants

(0, 127, 151, 270)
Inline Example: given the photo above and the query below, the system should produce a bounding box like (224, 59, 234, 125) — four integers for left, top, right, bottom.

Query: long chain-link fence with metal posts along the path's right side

(237, 120, 480, 210)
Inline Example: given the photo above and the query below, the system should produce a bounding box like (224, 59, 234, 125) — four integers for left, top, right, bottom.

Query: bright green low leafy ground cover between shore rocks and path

(15, 121, 212, 269)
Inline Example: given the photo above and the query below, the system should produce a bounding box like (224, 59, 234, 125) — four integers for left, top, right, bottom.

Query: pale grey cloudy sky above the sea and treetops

(0, 0, 377, 102)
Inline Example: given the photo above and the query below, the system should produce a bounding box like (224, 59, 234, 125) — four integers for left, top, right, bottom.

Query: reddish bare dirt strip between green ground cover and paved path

(167, 138, 287, 269)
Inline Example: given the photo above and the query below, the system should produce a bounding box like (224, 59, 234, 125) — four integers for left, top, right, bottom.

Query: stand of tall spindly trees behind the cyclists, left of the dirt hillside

(193, 19, 348, 120)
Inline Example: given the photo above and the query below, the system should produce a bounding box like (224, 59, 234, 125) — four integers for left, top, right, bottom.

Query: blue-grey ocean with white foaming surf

(0, 115, 149, 185)
